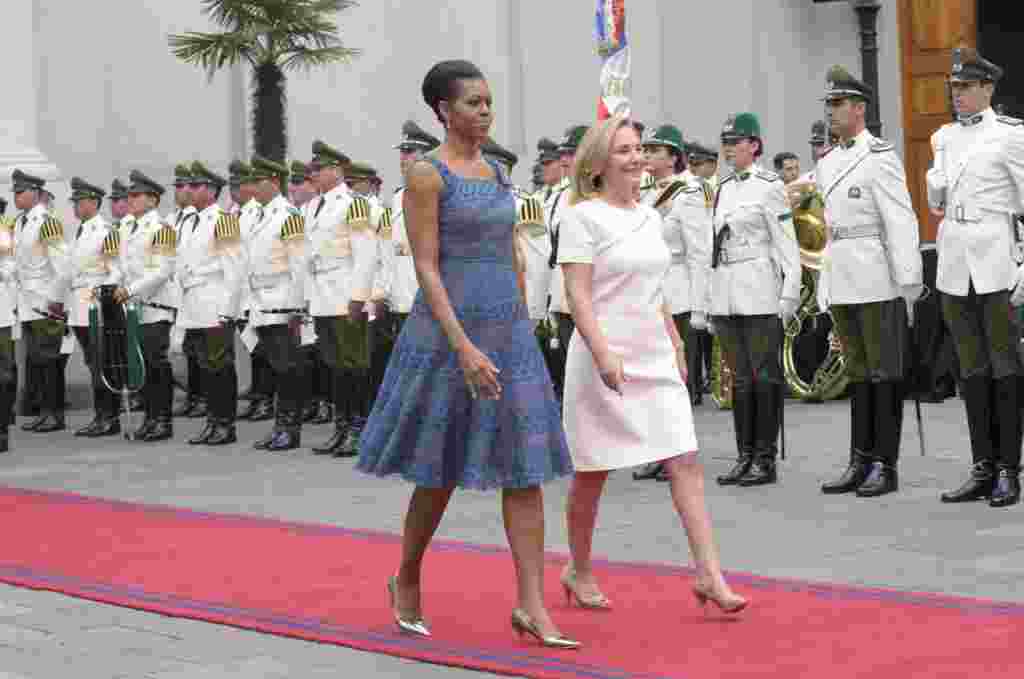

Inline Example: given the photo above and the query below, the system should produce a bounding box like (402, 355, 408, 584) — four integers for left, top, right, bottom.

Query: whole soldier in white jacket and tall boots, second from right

(815, 67, 922, 498)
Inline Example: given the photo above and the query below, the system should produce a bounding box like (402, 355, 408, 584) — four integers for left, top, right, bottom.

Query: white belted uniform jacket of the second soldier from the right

(815, 130, 923, 309)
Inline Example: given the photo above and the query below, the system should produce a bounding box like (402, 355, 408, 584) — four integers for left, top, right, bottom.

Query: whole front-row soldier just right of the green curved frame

(114, 170, 181, 441)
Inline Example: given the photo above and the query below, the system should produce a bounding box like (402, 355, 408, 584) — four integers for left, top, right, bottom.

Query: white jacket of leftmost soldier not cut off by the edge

(14, 205, 68, 323)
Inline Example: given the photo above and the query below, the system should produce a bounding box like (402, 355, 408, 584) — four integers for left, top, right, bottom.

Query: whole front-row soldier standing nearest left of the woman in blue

(306, 140, 377, 457)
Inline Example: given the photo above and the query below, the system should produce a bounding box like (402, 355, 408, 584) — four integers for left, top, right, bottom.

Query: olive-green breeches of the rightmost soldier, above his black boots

(942, 283, 1021, 380)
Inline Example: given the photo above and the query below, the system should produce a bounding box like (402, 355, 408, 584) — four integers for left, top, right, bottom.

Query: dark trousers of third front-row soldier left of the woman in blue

(183, 326, 239, 423)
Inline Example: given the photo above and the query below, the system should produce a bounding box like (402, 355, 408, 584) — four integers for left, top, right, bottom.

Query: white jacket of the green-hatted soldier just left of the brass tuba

(708, 165, 800, 315)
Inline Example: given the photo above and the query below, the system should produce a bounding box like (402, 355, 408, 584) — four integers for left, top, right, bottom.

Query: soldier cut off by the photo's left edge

(0, 198, 17, 453)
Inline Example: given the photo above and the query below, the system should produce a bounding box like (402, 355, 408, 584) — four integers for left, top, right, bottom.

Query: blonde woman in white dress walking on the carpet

(558, 116, 746, 612)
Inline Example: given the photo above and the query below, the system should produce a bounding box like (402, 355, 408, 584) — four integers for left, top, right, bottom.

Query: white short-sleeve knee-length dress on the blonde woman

(558, 199, 697, 471)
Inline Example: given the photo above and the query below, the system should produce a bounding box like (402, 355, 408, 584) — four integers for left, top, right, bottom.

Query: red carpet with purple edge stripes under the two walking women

(0, 486, 1024, 679)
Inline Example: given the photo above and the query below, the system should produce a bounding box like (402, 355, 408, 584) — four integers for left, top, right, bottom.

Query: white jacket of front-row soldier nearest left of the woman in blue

(306, 184, 377, 316)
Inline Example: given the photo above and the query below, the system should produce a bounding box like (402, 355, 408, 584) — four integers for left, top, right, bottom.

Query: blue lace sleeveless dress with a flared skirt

(356, 159, 572, 490)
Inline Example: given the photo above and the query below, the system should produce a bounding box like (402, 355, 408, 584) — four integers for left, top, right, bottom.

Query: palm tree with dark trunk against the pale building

(168, 0, 360, 161)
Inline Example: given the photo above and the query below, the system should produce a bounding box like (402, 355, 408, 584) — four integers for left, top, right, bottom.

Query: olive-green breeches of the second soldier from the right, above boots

(831, 297, 910, 383)
